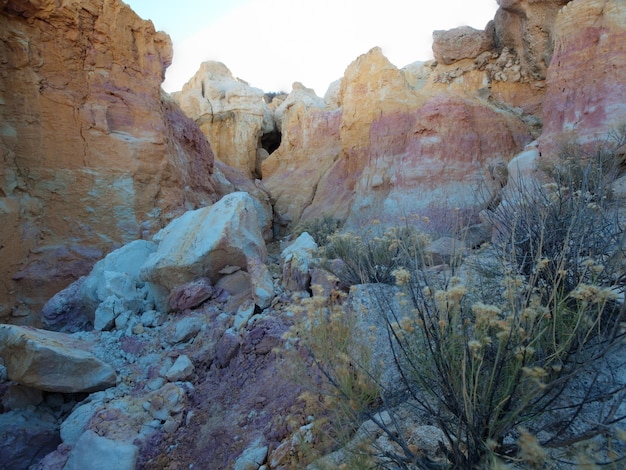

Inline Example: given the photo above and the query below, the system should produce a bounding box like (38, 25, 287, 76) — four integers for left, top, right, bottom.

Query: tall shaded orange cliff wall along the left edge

(0, 0, 215, 323)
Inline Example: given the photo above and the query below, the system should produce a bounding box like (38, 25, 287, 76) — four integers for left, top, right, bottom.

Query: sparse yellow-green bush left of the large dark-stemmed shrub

(287, 286, 380, 469)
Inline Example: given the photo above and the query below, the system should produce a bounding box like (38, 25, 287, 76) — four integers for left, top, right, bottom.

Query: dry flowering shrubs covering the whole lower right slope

(292, 130, 626, 469)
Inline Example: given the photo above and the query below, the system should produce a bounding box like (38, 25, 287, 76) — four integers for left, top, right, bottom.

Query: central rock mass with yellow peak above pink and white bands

(263, 48, 532, 231)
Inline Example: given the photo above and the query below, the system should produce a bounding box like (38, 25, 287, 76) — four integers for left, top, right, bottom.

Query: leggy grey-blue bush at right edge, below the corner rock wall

(490, 132, 626, 298)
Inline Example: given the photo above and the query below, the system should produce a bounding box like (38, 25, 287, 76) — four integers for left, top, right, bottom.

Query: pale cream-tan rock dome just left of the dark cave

(173, 61, 274, 177)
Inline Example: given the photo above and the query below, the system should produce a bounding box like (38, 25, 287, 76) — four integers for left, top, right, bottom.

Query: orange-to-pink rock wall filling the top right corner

(539, 0, 626, 156)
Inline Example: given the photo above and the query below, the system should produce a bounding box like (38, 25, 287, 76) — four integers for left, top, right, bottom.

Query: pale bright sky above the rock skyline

(124, 0, 498, 96)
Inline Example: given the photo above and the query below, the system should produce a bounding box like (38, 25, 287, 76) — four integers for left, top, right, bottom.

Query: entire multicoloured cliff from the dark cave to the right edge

(262, 0, 626, 231)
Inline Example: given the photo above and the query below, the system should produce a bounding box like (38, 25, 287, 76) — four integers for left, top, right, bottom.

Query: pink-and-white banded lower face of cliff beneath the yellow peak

(349, 95, 532, 231)
